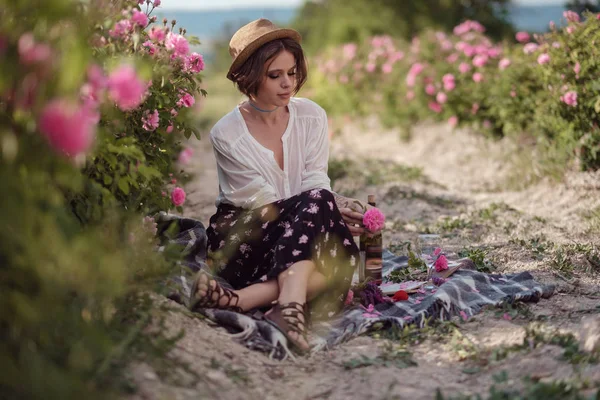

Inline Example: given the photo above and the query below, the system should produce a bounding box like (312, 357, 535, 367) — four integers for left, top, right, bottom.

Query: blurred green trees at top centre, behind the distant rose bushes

(293, 0, 513, 51)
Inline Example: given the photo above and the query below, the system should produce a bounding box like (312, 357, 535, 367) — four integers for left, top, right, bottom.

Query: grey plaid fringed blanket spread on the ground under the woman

(155, 213, 555, 359)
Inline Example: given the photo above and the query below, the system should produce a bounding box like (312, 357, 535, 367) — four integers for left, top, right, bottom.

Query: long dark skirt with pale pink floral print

(207, 189, 358, 319)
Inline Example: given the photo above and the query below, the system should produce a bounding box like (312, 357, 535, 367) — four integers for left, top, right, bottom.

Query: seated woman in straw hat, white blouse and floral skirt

(190, 19, 378, 352)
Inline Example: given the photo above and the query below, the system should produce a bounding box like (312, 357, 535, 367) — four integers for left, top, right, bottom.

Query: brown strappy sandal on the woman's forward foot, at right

(264, 301, 309, 354)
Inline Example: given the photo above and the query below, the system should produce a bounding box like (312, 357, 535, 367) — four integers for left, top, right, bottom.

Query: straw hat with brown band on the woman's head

(227, 18, 302, 81)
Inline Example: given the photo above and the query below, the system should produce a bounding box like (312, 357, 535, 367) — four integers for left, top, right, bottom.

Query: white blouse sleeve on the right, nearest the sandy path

(301, 109, 331, 192)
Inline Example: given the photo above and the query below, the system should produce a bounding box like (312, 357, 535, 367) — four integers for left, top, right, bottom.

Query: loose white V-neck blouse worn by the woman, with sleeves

(210, 97, 331, 209)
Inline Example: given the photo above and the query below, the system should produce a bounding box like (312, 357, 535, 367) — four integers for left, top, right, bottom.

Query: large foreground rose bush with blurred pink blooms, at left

(0, 0, 204, 398)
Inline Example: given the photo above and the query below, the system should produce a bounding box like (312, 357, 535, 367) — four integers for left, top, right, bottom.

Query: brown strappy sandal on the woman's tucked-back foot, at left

(188, 271, 244, 313)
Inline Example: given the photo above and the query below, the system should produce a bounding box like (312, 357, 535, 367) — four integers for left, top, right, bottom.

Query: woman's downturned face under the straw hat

(255, 50, 296, 107)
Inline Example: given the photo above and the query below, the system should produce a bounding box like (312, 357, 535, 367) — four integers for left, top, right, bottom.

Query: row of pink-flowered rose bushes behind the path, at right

(309, 11, 600, 170)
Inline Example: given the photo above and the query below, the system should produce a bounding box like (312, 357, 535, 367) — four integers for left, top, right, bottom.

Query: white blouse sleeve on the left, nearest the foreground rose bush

(210, 134, 277, 209)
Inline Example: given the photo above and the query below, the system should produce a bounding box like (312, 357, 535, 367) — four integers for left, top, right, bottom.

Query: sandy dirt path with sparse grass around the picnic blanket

(133, 116, 600, 400)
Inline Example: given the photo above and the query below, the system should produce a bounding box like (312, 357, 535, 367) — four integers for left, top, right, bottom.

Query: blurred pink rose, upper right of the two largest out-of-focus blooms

(108, 64, 146, 111)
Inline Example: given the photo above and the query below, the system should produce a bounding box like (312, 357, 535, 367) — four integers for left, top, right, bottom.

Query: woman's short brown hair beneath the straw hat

(233, 38, 308, 97)
